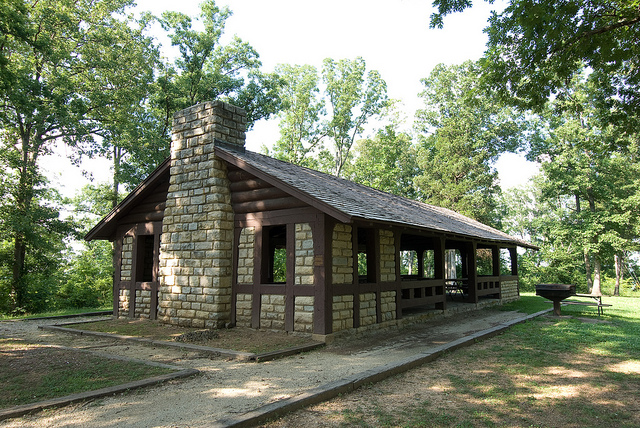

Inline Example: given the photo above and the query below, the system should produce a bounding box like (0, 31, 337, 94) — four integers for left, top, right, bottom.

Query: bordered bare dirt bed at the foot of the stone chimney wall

(65, 319, 312, 354)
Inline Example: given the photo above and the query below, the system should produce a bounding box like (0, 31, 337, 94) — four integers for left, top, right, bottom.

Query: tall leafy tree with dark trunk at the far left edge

(0, 0, 155, 306)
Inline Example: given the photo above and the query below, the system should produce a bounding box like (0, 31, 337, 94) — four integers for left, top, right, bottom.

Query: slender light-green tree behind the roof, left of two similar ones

(272, 64, 325, 168)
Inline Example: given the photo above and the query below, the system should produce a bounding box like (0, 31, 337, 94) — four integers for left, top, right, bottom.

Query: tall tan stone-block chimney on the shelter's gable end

(158, 101, 247, 328)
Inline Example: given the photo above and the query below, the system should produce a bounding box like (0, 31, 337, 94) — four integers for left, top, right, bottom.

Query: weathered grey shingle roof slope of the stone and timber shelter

(216, 147, 536, 248)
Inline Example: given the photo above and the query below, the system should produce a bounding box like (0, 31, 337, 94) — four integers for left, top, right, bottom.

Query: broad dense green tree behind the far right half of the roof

(415, 61, 526, 225)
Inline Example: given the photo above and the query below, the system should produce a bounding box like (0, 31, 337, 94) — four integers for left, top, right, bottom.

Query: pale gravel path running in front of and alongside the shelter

(0, 309, 523, 427)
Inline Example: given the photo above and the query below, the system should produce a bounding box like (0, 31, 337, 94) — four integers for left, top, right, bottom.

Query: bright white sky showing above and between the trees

(43, 0, 536, 196)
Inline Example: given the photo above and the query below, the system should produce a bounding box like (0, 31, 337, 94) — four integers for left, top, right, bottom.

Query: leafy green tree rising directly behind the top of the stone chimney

(153, 0, 281, 135)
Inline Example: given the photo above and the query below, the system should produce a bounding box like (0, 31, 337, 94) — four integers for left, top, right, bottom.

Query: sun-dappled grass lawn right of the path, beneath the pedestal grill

(268, 295, 640, 428)
